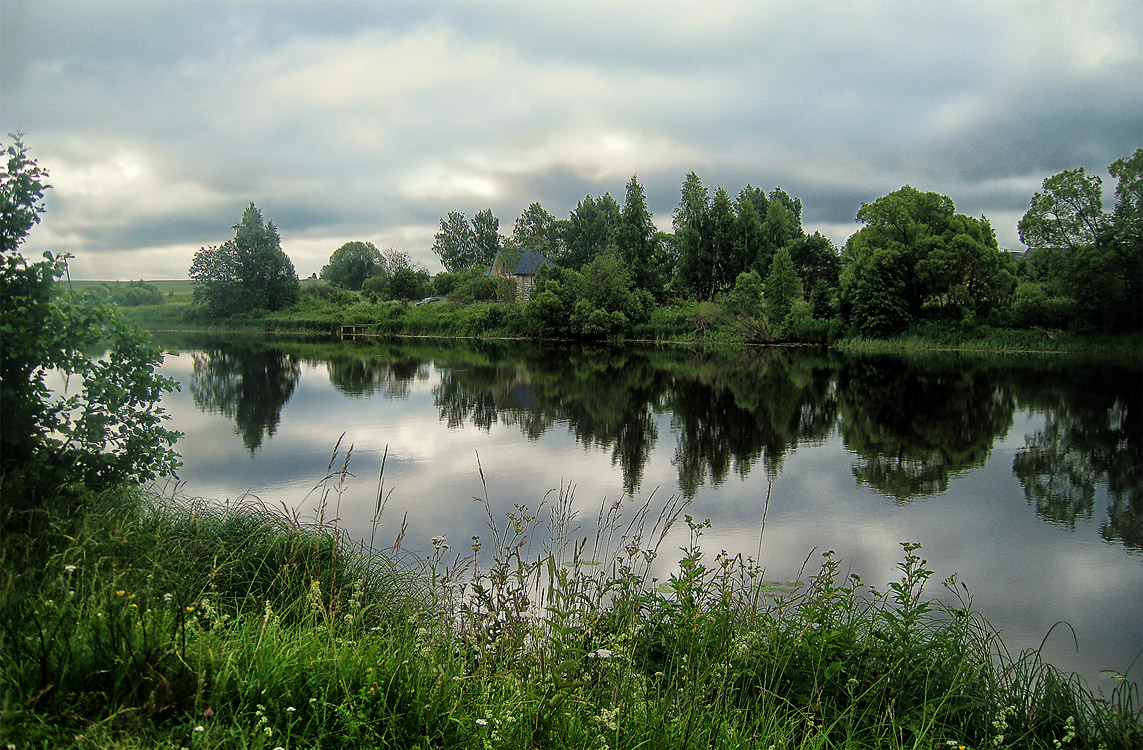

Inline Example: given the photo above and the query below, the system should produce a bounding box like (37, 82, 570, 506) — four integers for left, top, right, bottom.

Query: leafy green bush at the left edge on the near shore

(0, 135, 178, 487)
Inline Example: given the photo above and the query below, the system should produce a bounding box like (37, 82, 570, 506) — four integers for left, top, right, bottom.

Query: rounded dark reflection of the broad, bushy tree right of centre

(840, 357, 1013, 502)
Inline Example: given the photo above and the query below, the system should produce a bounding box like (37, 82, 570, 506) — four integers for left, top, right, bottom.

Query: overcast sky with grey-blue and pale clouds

(0, 0, 1143, 279)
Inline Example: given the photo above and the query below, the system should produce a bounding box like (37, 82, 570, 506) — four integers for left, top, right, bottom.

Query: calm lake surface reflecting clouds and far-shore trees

(159, 336, 1143, 686)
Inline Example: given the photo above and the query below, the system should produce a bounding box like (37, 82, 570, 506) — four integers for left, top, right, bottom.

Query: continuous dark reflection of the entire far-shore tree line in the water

(171, 333, 1143, 550)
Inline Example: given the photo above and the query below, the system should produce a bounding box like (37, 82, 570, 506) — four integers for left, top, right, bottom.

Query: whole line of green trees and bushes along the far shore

(182, 150, 1143, 338)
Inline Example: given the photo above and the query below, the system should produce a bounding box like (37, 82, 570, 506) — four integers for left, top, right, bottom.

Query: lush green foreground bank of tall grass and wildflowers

(0, 462, 1143, 749)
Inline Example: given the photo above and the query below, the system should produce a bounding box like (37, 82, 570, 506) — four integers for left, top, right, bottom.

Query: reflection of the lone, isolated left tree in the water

(191, 346, 299, 454)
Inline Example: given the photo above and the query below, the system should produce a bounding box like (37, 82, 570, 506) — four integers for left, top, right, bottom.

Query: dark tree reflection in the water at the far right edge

(1013, 364, 1143, 550)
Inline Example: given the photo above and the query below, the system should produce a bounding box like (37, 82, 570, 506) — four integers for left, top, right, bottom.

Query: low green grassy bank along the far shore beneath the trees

(122, 293, 1143, 356)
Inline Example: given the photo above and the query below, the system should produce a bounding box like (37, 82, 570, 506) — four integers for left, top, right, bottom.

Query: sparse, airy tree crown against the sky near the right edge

(1016, 167, 1104, 249)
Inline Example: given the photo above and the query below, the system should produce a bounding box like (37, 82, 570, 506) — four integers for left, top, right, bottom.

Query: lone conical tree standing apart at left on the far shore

(190, 202, 298, 317)
